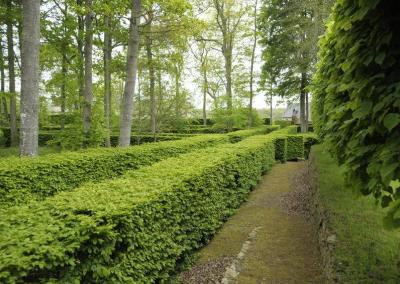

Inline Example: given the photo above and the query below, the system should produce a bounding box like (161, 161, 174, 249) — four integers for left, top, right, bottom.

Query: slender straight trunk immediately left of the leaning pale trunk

(104, 13, 112, 147)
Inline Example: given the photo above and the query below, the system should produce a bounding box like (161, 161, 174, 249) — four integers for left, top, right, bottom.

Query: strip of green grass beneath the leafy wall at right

(312, 145, 400, 283)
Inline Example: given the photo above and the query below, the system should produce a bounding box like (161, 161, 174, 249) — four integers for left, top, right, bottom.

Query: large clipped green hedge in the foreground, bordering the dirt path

(0, 135, 275, 283)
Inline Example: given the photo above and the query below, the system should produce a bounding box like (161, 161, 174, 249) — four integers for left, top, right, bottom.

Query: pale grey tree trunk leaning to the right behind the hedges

(119, 0, 142, 147)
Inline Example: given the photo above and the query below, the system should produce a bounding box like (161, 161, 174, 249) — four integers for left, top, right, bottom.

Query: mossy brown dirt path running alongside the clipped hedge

(182, 162, 324, 284)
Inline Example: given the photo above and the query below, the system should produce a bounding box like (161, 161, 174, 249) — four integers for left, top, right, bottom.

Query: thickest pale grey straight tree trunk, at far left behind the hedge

(20, 0, 40, 156)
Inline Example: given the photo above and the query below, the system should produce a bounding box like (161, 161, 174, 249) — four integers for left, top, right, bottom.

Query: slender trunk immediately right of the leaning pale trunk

(146, 29, 157, 135)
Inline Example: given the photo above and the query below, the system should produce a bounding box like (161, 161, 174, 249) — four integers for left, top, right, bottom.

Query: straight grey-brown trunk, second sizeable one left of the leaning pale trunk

(83, 0, 93, 143)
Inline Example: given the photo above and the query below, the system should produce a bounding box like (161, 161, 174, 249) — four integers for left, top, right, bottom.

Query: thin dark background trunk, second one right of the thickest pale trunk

(75, 0, 85, 109)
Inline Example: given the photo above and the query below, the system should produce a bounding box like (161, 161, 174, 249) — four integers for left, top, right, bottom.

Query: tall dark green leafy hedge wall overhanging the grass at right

(313, 0, 400, 215)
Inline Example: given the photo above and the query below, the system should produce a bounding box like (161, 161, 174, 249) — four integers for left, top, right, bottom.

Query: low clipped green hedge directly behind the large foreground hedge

(0, 135, 228, 207)
